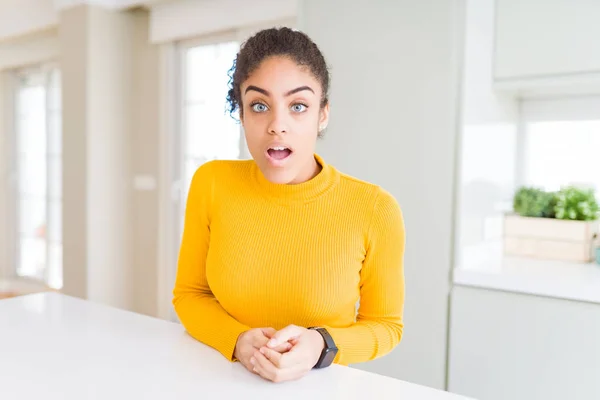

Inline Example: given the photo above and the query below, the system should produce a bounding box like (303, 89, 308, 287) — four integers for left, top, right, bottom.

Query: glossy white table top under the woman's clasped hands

(0, 293, 474, 400)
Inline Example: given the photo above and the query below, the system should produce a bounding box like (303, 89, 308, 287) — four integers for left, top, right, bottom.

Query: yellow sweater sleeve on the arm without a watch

(173, 162, 250, 361)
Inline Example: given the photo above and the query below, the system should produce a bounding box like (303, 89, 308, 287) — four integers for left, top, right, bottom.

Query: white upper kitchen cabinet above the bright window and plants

(494, 0, 600, 81)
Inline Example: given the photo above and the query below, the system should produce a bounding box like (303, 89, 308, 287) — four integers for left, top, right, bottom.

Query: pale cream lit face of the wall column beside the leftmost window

(86, 7, 134, 308)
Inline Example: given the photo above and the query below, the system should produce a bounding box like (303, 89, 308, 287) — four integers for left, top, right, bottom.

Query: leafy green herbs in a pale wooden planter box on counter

(504, 186, 599, 262)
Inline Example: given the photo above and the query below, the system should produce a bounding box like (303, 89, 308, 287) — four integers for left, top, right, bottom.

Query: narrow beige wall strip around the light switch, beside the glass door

(129, 10, 161, 316)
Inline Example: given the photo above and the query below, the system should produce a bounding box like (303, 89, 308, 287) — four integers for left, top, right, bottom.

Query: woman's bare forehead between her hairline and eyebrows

(242, 57, 321, 95)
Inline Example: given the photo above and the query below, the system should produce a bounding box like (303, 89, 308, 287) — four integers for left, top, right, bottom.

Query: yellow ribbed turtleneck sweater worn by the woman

(173, 155, 405, 365)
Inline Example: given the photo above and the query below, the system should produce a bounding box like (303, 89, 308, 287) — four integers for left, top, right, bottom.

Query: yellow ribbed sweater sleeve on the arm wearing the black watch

(326, 189, 405, 365)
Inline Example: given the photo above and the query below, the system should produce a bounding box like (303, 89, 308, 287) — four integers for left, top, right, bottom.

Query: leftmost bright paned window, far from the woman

(13, 67, 62, 289)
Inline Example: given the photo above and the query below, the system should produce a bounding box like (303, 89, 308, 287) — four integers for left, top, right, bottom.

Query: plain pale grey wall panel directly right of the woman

(299, 0, 464, 388)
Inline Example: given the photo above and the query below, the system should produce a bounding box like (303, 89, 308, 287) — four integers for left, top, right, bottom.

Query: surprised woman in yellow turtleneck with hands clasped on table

(173, 28, 405, 381)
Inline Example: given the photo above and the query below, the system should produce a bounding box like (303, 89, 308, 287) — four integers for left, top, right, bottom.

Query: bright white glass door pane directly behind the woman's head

(178, 41, 245, 233)
